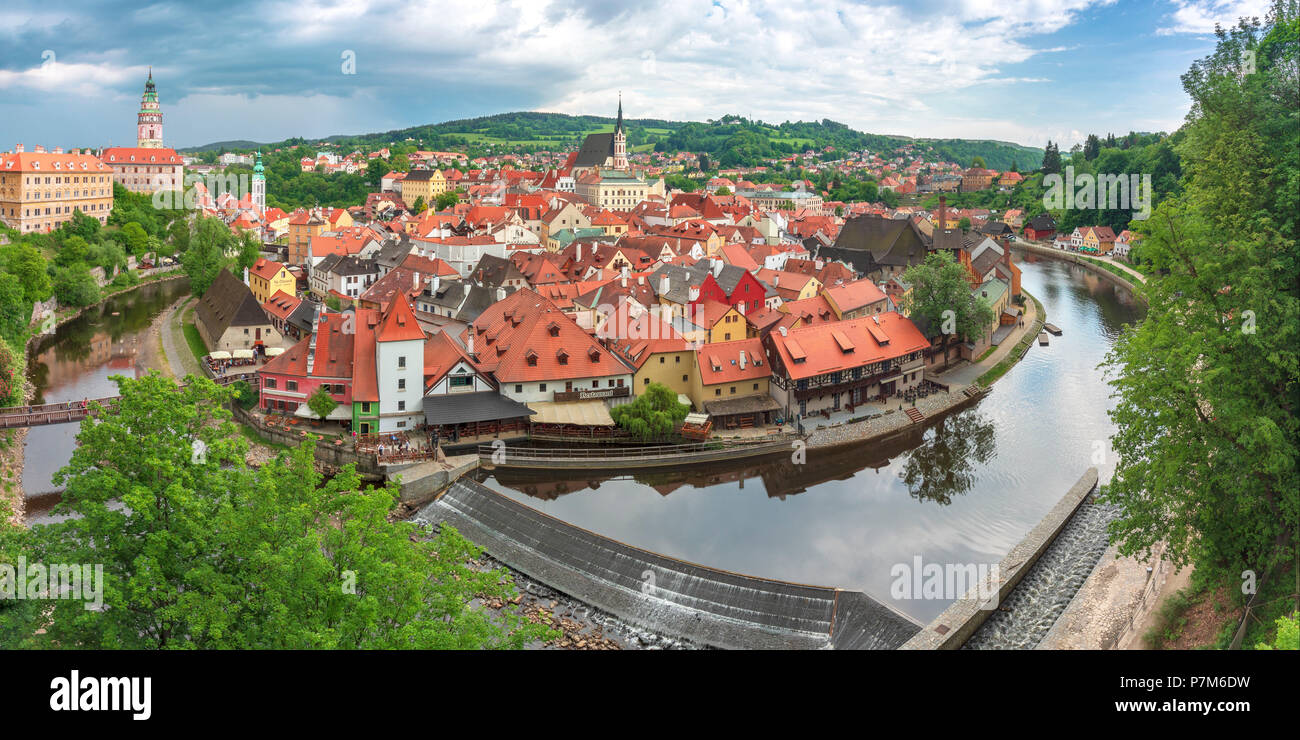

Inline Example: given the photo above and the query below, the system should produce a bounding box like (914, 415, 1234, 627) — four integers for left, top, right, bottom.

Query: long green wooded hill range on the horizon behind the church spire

(183, 112, 1043, 170)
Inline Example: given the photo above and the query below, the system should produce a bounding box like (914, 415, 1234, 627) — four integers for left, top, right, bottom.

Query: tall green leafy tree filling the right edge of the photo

(1105, 3, 1300, 581)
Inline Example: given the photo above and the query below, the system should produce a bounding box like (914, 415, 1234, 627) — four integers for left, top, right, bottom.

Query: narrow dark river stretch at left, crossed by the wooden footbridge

(22, 280, 190, 502)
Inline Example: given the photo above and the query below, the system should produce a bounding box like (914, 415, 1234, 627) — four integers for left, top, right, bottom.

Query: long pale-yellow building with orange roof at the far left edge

(0, 146, 113, 231)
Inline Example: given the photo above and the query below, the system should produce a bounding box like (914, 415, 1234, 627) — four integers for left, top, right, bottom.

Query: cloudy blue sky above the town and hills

(0, 0, 1269, 151)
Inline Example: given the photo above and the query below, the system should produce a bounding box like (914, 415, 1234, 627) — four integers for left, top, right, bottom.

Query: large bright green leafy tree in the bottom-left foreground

(12, 373, 554, 649)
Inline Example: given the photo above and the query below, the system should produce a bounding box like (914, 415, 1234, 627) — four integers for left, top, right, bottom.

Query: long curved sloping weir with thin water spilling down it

(415, 479, 920, 649)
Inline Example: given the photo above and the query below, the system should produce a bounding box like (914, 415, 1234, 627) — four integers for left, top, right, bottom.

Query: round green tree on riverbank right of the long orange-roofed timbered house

(902, 251, 993, 367)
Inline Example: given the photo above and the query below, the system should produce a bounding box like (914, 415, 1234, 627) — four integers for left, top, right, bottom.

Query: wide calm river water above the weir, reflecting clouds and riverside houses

(482, 255, 1140, 622)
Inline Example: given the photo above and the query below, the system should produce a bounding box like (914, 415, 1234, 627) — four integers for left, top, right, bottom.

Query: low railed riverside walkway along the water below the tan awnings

(478, 436, 796, 469)
